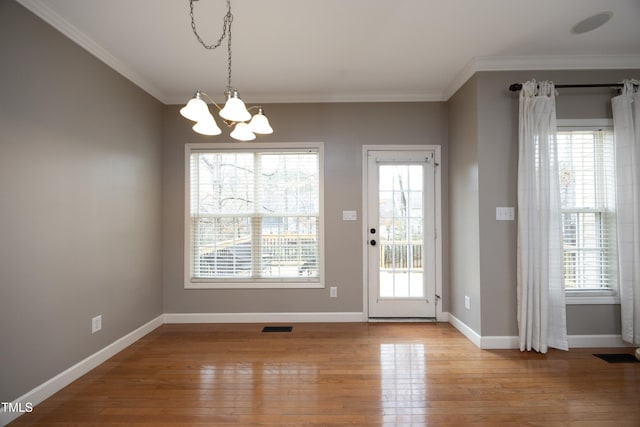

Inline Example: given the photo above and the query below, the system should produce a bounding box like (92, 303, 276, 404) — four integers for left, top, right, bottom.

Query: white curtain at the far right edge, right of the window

(611, 80, 640, 344)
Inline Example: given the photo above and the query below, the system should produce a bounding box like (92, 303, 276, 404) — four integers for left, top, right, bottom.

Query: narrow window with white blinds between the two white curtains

(557, 121, 617, 295)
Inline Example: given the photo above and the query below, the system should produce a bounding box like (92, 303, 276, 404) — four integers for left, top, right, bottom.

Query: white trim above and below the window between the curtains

(556, 119, 620, 305)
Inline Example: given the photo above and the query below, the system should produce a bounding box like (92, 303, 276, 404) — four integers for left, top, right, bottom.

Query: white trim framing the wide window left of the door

(183, 142, 325, 289)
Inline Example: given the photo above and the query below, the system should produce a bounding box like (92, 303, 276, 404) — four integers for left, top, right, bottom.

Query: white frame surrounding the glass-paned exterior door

(362, 145, 447, 322)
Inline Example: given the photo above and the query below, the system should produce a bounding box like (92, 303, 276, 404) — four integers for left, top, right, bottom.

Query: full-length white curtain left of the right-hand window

(518, 80, 569, 353)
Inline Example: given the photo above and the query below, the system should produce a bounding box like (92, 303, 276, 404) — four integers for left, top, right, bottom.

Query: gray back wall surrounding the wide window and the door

(163, 103, 448, 313)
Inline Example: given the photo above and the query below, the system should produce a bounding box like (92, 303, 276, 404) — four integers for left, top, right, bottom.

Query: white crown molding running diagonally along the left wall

(17, 0, 167, 104)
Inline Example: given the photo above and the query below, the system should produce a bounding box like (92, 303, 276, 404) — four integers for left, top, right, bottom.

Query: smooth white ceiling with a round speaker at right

(18, 0, 640, 104)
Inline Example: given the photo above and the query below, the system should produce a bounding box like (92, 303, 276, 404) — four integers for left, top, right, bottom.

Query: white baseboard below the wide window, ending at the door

(164, 312, 367, 323)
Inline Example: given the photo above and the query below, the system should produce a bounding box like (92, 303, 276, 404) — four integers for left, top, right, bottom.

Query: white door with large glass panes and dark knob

(366, 150, 436, 318)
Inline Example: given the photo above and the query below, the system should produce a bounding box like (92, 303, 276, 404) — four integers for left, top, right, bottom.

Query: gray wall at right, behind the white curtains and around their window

(449, 70, 640, 336)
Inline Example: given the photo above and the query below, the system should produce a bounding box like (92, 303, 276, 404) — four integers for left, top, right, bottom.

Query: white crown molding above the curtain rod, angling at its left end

(444, 55, 640, 101)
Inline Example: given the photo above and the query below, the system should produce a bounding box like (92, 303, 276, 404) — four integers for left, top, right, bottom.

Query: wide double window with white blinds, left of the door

(185, 143, 323, 288)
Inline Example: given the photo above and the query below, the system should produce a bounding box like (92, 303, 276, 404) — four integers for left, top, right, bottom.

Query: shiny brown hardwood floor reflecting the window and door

(10, 323, 640, 427)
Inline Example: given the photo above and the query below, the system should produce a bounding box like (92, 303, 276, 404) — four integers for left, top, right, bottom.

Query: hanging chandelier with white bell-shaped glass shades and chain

(180, 0, 273, 141)
